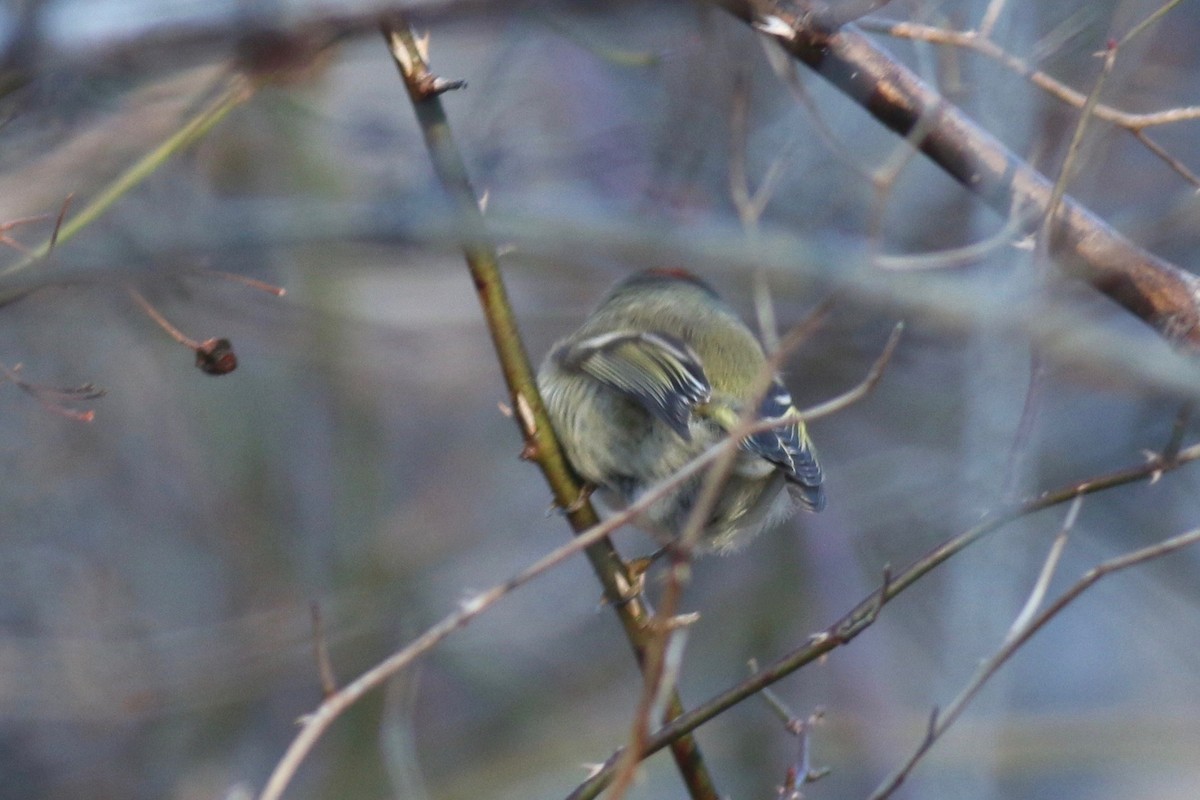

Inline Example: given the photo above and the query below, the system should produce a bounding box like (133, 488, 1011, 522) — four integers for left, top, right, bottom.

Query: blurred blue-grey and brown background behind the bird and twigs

(0, 0, 1200, 800)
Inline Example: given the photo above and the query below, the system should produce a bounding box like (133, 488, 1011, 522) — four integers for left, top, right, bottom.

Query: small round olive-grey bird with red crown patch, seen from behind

(538, 270, 826, 552)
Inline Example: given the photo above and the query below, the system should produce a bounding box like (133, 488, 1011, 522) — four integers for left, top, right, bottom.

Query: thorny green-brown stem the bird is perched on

(380, 14, 718, 800)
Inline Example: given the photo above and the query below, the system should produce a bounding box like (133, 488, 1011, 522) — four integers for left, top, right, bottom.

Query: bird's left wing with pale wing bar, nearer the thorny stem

(558, 331, 713, 440)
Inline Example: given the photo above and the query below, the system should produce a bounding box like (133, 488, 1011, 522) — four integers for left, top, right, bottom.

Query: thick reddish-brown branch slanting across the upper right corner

(714, 0, 1200, 350)
